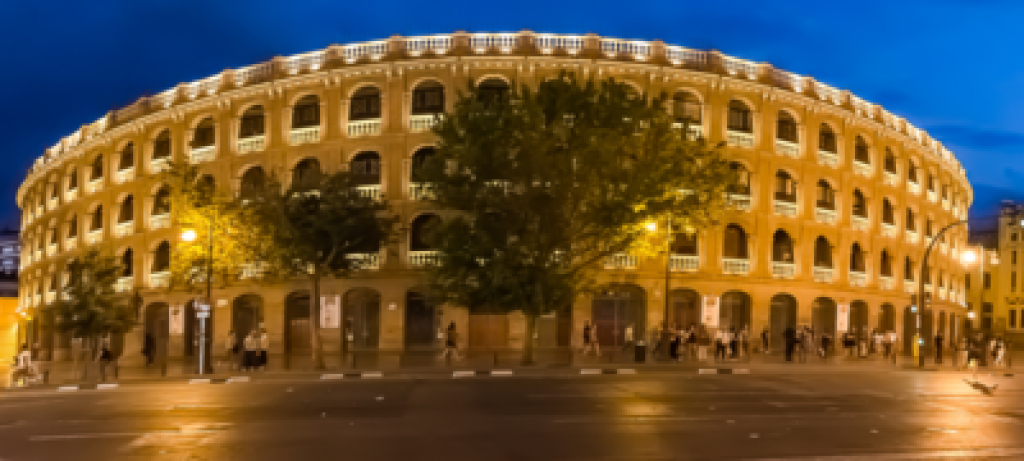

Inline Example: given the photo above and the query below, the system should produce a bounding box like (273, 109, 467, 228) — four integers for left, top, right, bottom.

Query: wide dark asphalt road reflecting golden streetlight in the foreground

(0, 372, 1024, 461)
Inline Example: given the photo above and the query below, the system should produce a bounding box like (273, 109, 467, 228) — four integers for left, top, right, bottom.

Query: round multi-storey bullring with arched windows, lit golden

(17, 31, 972, 363)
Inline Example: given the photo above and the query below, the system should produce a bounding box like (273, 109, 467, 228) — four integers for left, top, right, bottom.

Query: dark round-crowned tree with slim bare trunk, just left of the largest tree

(245, 169, 395, 369)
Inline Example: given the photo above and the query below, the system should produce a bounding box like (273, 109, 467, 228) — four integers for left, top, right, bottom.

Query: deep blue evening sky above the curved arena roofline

(0, 0, 1024, 226)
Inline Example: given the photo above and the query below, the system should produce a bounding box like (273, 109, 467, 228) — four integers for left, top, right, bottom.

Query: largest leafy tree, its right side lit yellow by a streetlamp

(422, 73, 735, 364)
